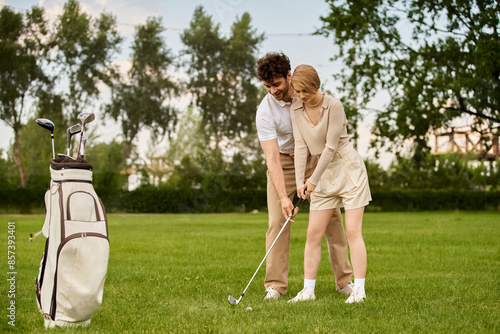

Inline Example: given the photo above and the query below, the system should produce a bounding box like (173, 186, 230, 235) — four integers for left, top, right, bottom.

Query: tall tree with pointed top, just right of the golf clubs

(106, 18, 178, 158)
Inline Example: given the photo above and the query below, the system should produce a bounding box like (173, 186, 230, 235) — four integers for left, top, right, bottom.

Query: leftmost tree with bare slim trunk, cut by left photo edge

(0, 6, 48, 188)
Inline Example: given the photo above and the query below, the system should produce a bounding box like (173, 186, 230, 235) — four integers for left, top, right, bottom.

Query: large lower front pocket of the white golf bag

(50, 232, 109, 321)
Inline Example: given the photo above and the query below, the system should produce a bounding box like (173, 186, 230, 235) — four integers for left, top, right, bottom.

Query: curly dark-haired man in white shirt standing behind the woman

(256, 53, 353, 300)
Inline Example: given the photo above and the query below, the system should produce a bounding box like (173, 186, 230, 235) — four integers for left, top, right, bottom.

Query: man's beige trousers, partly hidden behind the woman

(264, 155, 353, 294)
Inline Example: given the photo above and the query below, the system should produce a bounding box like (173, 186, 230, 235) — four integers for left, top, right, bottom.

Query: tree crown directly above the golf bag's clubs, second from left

(51, 0, 122, 119)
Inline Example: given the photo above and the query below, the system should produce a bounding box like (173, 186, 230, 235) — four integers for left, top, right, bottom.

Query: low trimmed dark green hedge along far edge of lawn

(0, 187, 500, 213)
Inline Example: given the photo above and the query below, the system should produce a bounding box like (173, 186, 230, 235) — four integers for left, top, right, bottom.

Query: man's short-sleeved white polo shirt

(255, 93, 294, 154)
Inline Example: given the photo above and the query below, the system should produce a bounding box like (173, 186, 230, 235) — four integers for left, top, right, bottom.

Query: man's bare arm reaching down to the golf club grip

(260, 139, 293, 219)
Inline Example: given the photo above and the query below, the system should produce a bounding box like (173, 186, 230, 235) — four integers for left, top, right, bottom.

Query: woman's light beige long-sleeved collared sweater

(290, 94, 349, 189)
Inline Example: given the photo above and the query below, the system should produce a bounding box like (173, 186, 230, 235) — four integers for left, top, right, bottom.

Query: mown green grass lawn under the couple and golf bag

(0, 212, 500, 333)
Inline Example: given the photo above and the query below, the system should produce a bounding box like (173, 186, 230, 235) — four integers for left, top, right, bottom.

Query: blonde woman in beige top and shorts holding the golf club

(290, 65, 371, 303)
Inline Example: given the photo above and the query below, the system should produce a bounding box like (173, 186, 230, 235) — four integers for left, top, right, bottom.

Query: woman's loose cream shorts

(311, 143, 372, 210)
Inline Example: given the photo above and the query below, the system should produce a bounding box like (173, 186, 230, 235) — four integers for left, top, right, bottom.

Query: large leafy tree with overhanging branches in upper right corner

(318, 0, 500, 157)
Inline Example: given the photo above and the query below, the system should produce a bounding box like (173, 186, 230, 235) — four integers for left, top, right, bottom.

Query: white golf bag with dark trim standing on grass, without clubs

(36, 158, 109, 328)
